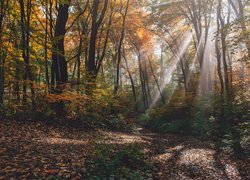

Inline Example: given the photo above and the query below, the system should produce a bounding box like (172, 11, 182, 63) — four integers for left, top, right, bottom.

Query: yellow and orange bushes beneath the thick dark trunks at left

(0, 83, 135, 130)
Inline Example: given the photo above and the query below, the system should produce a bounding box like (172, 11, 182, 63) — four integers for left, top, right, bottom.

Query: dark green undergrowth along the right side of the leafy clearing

(138, 94, 250, 157)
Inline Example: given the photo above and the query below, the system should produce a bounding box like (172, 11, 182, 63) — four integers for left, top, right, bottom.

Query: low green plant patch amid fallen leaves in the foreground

(85, 144, 151, 180)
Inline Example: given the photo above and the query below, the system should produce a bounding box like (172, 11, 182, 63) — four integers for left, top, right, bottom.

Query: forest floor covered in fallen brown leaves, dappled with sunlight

(0, 120, 250, 180)
